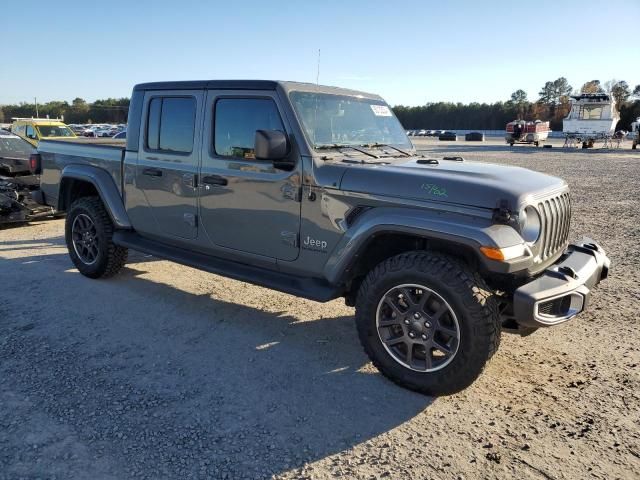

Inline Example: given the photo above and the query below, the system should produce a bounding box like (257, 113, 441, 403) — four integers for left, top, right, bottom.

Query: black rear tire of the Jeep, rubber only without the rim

(65, 197, 128, 278)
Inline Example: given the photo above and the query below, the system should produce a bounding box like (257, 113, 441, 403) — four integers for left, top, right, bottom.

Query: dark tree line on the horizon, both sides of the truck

(0, 77, 640, 130)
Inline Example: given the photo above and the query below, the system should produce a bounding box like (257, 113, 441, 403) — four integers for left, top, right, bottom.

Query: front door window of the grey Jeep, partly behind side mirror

(214, 98, 284, 159)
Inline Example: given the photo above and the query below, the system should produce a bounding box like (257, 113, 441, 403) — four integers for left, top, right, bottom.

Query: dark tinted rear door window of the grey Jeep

(147, 97, 196, 153)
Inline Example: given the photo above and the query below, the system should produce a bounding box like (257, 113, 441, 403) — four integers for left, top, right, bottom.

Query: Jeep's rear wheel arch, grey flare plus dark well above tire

(58, 165, 131, 229)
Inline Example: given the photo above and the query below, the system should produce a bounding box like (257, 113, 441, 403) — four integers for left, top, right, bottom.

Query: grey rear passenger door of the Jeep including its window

(136, 90, 204, 240)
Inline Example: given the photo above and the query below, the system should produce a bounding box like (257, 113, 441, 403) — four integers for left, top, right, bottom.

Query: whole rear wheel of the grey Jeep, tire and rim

(65, 197, 128, 278)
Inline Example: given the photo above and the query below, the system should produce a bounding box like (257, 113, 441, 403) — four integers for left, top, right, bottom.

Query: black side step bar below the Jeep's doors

(113, 230, 340, 302)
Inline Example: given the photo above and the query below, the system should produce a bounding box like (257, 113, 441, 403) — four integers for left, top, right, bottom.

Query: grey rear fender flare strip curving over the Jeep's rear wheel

(58, 165, 132, 229)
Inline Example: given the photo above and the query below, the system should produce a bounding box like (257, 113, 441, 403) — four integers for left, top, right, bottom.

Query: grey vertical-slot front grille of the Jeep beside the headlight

(538, 193, 571, 260)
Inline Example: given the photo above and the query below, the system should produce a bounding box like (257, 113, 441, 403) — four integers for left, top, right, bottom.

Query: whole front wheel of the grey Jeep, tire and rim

(356, 252, 500, 395)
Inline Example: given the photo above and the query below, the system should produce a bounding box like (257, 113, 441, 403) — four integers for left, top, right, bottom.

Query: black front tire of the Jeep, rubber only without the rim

(356, 251, 500, 396)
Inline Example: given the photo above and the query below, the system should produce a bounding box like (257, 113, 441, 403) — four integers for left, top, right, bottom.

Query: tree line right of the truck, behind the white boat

(393, 77, 640, 130)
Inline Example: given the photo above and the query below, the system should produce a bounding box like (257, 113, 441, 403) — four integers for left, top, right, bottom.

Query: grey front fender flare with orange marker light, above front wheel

(324, 204, 533, 283)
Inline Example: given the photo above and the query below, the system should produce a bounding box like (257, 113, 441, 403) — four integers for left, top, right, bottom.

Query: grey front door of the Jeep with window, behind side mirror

(199, 90, 302, 260)
